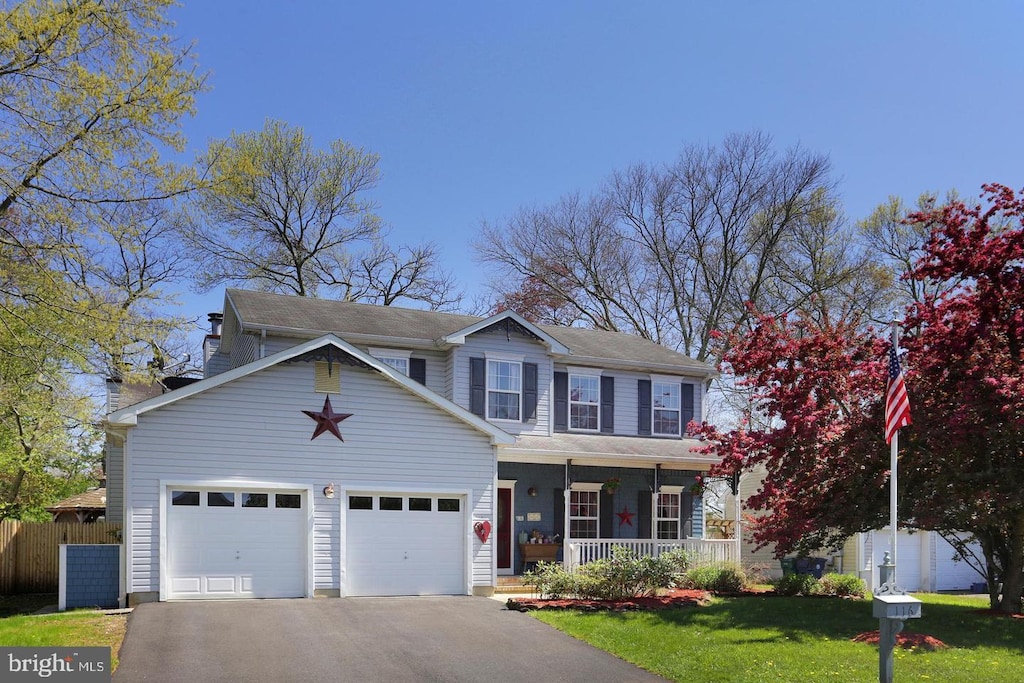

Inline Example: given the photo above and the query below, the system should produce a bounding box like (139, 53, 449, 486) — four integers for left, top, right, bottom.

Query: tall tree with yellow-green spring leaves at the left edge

(0, 0, 203, 516)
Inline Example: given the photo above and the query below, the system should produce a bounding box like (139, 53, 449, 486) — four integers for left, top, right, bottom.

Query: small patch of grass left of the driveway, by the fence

(0, 596, 128, 669)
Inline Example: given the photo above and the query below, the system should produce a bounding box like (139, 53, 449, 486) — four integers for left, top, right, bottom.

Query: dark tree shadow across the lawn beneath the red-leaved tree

(593, 597, 1024, 652)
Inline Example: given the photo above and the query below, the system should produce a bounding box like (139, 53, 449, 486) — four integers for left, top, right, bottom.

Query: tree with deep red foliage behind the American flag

(698, 185, 1024, 612)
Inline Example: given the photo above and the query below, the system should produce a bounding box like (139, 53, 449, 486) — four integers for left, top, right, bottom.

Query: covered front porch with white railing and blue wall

(496, 434, 739, 575)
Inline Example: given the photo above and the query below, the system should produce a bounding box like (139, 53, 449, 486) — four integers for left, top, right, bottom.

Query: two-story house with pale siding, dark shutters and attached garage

(108, 289, 715, 602)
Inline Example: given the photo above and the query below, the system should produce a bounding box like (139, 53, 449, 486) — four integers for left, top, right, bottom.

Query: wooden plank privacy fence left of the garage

(0, 519, 121, 595)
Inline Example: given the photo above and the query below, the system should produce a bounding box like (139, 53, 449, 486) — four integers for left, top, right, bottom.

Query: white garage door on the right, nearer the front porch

(344, 493, 467, 595)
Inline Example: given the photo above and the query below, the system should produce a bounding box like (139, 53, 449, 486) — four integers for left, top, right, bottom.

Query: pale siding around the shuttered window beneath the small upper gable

(451, 331, 552, 435)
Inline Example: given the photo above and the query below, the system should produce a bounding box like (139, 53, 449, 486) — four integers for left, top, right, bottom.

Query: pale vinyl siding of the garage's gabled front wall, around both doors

(127, 362, 496, 592)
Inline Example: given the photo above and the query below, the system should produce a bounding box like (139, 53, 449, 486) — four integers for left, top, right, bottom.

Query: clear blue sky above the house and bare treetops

(171, 0, 1024, 335)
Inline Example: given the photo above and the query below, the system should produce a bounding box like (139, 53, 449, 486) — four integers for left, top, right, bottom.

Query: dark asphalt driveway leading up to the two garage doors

(114, 597, 663, 683)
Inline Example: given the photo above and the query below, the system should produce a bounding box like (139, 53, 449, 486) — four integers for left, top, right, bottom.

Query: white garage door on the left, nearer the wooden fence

(166, 487, 308, 599)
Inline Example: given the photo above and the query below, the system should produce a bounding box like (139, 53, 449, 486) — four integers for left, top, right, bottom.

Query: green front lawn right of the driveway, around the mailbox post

(531, 595, 1024, 683)
